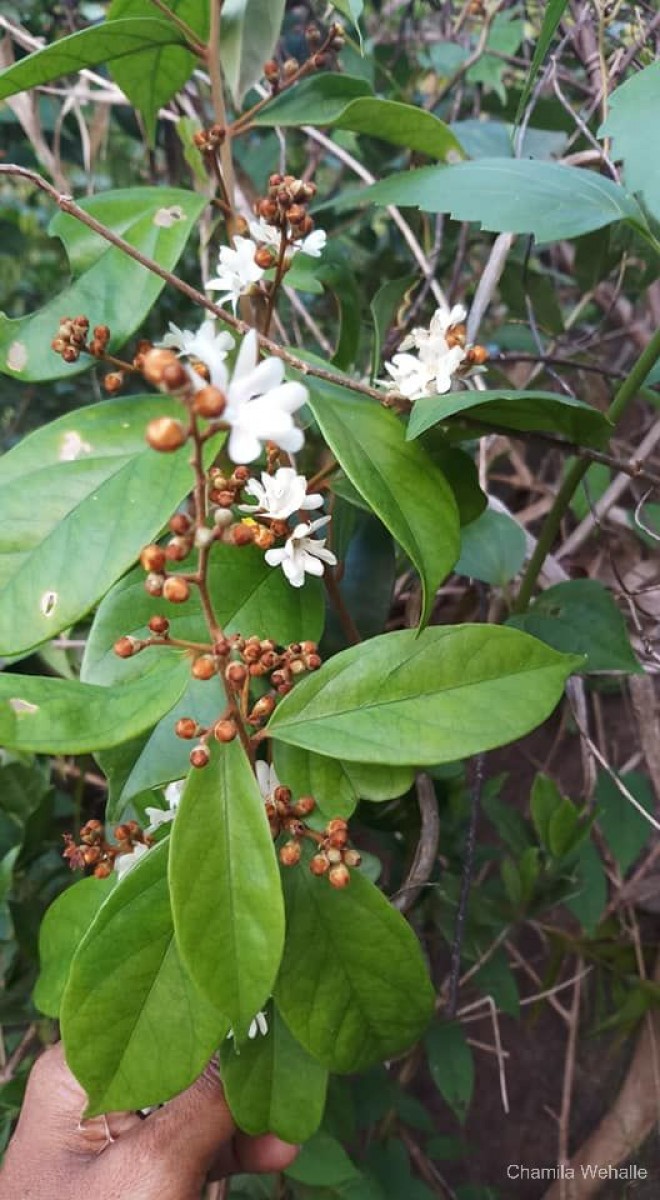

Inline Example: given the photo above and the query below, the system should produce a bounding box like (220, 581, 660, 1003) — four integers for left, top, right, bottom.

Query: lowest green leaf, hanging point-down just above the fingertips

(221, 1009, 328, 1144)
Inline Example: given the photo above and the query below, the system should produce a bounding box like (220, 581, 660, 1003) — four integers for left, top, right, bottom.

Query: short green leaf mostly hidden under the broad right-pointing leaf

(275, 742, 414, 820)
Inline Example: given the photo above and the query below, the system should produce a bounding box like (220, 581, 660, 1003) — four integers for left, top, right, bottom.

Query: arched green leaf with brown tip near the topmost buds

(253, 74, 464, 160)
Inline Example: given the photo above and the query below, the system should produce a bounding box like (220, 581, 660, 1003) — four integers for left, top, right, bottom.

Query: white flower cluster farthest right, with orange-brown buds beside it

(385, 305, 487, 400)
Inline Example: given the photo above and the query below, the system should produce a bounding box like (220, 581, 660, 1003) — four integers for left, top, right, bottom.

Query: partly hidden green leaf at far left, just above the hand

(35, 874, 116, 1018)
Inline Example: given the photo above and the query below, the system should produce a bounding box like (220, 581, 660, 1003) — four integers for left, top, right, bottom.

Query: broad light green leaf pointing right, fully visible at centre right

(268, 625, 581, 766)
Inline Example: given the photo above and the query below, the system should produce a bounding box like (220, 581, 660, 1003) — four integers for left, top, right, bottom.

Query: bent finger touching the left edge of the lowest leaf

(140, 1063, 236, 1174)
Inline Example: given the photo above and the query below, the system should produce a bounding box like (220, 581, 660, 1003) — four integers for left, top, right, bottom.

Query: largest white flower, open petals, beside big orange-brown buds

(219, 329, 307, 462)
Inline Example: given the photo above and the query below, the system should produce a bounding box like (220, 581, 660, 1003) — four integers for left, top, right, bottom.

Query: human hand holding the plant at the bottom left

(0, 1045, 298, 1200)
